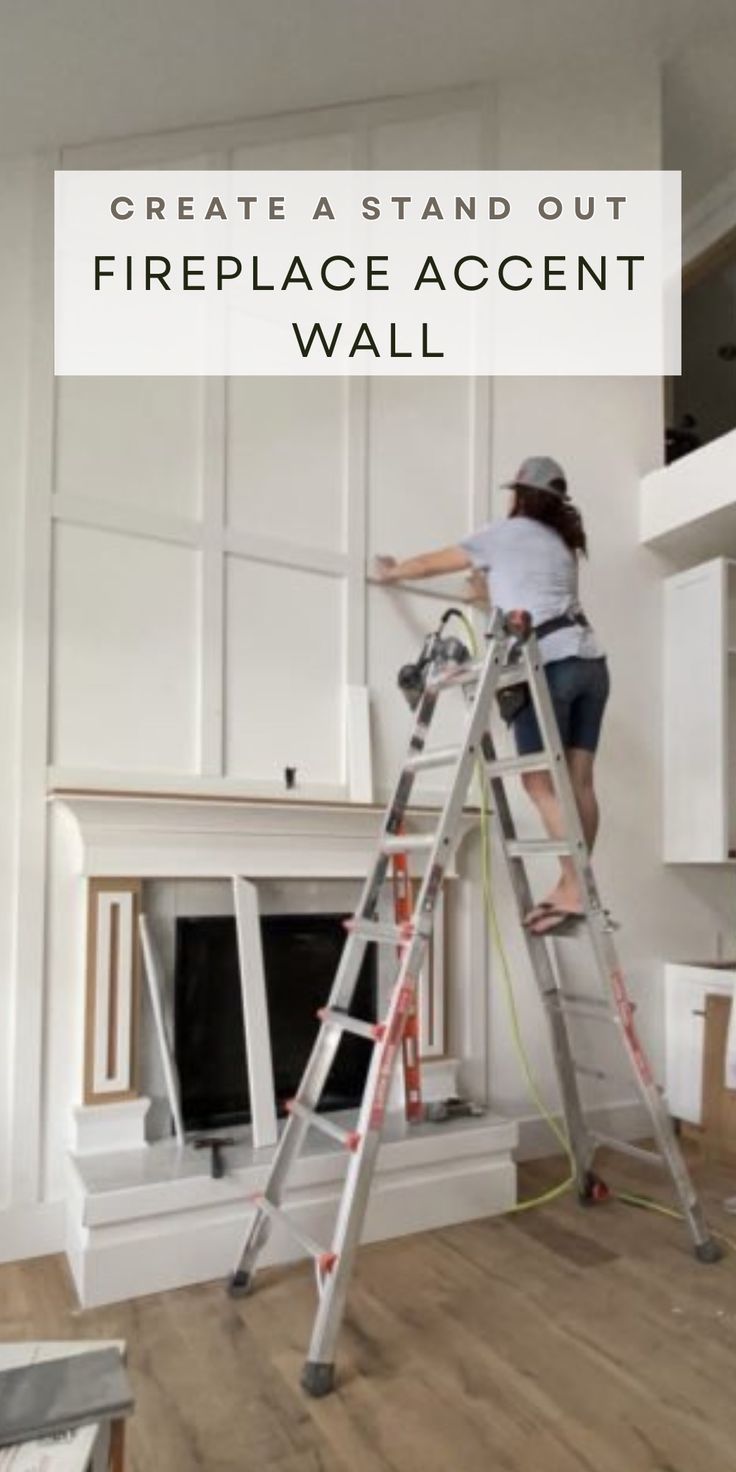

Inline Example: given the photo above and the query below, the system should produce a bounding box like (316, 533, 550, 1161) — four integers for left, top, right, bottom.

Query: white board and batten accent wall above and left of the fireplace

(0, 88, 493, 1257)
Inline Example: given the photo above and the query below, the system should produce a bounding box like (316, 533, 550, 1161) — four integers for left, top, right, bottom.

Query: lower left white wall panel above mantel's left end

(52, 526, 197, 773)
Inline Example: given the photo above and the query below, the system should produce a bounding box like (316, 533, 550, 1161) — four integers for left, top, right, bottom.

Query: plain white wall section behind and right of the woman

(490, 69, 733, 1111)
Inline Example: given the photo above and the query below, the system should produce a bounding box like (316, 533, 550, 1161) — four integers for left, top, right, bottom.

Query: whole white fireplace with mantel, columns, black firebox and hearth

(55, 793, 517, 1307)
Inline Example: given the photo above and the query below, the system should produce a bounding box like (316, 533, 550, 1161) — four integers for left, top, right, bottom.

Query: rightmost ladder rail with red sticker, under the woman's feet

(526, 636, 710, 1248)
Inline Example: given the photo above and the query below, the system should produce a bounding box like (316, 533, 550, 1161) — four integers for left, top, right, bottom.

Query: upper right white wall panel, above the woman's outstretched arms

(368, 378, 473, 556)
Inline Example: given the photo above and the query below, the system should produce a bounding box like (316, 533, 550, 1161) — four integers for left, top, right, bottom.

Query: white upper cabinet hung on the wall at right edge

(664, 558, 736, 864)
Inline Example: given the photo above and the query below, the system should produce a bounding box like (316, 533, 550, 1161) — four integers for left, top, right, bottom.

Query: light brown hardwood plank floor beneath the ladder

(0, 1161, 736, 1472)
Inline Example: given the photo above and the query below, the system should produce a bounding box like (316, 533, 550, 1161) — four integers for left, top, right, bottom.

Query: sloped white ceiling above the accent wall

(0, 0, 736, 207)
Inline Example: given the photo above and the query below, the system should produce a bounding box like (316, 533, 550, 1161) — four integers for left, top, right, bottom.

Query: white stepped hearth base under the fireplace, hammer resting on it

(69, 1106, 518, 1307)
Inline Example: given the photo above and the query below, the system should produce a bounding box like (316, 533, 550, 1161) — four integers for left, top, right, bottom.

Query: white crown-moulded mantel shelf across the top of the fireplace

(52, 790, 478, 879)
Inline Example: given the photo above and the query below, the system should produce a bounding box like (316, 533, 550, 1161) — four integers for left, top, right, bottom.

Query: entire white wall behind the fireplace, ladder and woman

(0, 66, 730, 1250)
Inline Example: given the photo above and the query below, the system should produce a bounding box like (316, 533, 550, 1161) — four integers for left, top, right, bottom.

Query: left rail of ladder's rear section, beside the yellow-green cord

(483, 732, 595, 1191)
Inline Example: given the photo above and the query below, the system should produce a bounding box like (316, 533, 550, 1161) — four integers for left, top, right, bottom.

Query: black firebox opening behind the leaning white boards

(174, 913, 378, 1130)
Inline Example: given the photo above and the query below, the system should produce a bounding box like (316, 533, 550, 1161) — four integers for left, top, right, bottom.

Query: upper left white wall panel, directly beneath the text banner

(54, 378, 203, 517)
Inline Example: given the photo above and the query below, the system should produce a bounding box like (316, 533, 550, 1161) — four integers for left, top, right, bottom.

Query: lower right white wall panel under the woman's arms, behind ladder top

(368, 587, 465, 801)
